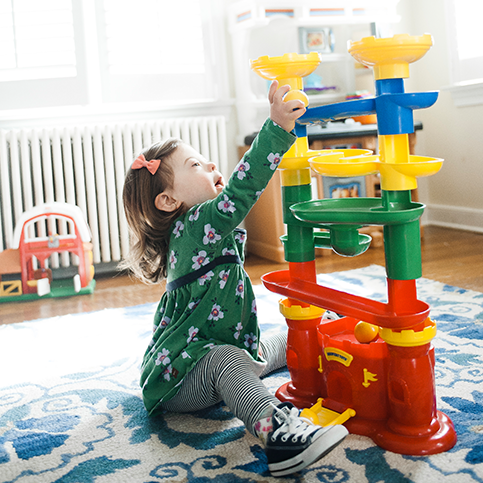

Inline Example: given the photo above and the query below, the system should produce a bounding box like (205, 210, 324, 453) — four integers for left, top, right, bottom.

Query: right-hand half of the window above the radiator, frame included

(97, 0, 215, 102)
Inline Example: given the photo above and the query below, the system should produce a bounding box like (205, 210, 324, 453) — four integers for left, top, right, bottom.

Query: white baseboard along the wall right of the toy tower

(424, 204, 483, 233)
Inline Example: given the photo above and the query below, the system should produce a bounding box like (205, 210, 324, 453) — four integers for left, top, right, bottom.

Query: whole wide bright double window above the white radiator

(0, 0, 222, 110)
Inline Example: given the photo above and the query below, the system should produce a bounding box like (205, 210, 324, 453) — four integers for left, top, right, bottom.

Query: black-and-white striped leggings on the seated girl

(161, 333, 287, 435)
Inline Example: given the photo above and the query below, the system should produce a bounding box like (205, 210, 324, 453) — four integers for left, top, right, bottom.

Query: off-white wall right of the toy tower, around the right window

(393, 0, 483, 232)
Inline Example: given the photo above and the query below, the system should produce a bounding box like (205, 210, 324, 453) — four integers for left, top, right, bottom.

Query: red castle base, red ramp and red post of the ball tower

(270, 271, 457, 456)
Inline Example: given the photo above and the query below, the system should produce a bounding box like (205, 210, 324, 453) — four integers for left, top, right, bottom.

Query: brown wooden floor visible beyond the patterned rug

(0, 226, 483, 324)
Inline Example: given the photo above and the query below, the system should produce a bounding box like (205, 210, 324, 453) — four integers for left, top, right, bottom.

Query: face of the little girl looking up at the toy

(161, 144, 225, 208)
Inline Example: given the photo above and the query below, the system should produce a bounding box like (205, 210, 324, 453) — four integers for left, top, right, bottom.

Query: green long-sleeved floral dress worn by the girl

(141, 119, 295, 414)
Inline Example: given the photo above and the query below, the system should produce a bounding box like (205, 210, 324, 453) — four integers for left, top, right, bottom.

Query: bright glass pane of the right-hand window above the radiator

(104, 0, 205, 74)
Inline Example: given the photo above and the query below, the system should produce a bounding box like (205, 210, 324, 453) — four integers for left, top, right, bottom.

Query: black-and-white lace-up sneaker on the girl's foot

(265, 402, 349, 476)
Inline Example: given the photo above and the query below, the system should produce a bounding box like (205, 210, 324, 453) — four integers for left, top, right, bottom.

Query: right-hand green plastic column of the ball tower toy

(382, 190, 422, 280)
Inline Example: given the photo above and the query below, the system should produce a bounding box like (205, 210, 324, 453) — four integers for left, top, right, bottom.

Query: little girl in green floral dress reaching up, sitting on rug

(123, 81, 347, 476)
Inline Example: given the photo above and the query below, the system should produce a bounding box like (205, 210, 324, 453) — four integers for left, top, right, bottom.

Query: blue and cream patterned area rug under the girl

(0, 266, 483, 483)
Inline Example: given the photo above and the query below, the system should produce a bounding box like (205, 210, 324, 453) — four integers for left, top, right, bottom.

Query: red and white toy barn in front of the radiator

(0, 203, 95, 303)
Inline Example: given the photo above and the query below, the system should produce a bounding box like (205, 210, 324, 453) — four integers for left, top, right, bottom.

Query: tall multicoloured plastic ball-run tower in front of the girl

(252, 35, 456, 455)
